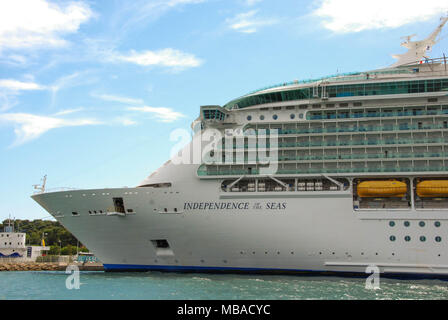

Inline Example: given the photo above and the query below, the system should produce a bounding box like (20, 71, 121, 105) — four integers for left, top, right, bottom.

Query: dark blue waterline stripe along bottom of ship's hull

(104, 264, 448, 280)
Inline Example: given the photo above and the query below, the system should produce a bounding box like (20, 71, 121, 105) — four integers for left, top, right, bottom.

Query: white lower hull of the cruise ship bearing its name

(33, 162, 448, 277)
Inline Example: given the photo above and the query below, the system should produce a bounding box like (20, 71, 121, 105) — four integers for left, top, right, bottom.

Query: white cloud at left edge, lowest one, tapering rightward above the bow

(0, 113, 101, 146)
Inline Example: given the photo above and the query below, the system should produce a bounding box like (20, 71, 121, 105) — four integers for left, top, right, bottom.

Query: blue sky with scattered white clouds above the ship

(0, 0, 448, 220)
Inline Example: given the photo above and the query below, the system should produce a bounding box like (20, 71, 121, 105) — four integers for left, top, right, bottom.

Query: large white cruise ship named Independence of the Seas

(32, 17, 448, 278)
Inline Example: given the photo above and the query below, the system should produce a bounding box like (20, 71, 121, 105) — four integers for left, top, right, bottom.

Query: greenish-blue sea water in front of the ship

(0, 271, 448, 300)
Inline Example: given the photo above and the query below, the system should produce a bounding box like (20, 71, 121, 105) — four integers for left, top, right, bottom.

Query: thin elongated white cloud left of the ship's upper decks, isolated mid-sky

(112, 48, 202, 69)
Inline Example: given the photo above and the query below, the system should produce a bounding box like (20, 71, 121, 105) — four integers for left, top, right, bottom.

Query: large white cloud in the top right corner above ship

(313, 0, 448, 33)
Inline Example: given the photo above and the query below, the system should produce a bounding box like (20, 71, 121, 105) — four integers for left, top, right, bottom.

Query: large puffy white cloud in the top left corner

(0, 0, 92, 48)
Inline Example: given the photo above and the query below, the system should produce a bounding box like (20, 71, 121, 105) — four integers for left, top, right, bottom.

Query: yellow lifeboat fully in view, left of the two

(358, 180, 408, 198)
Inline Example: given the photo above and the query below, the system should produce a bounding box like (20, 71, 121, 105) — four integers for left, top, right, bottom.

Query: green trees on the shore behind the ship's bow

(0, 219, 89, 255)
